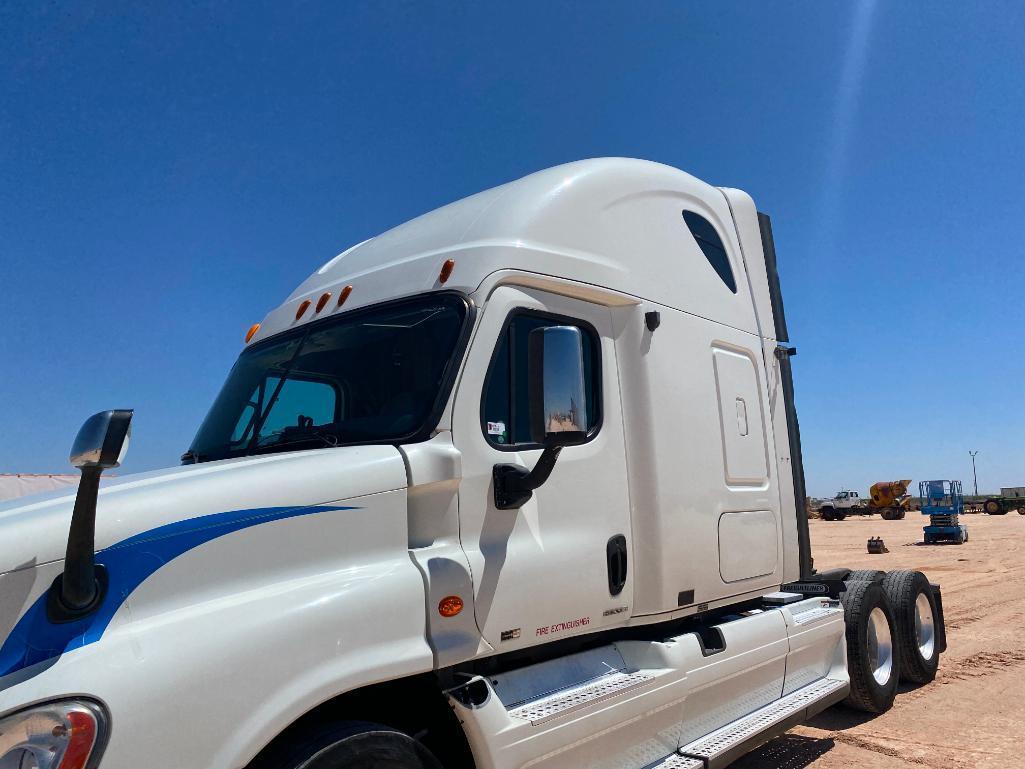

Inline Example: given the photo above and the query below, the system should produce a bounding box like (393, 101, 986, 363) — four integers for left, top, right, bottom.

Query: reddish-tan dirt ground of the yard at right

(733, 513, 1025, 769)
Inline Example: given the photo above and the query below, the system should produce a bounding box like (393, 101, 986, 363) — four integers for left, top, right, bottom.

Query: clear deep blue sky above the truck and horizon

(0, 2, 1025, 494)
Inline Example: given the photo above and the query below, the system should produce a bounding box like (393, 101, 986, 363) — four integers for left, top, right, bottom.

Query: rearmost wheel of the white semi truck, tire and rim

(883, 570, 940, 684)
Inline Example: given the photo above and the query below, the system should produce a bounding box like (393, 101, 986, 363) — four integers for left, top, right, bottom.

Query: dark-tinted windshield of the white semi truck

(182, 294, 466, 461)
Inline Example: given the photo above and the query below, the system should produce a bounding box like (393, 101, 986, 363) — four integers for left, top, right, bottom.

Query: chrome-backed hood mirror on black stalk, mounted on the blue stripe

(47, 409, 132, 622)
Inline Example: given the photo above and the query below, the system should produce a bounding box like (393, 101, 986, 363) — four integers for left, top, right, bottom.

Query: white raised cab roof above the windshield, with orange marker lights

(253, 158, 761, 340)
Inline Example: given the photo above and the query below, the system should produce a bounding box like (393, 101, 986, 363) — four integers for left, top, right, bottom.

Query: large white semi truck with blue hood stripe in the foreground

(0, 159, 945, 769)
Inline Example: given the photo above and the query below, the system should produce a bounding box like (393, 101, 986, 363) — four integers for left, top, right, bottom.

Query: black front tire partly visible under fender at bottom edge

(248, 722, 442, 769)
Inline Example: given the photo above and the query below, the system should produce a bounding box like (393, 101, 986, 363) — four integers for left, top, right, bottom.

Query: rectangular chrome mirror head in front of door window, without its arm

(527, 326, 587, 446)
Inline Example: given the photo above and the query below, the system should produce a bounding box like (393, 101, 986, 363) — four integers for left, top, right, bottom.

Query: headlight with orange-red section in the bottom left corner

(0, 699, 107, 769)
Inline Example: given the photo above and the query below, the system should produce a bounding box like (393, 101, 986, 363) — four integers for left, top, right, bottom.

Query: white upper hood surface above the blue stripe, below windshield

(0, 446, 407, 574)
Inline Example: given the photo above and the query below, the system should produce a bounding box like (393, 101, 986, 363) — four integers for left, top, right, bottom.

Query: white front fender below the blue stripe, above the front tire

(0, 488, 433, 769)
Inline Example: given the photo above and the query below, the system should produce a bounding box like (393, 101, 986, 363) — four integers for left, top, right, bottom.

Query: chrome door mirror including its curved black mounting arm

(492, 326, 587, 510)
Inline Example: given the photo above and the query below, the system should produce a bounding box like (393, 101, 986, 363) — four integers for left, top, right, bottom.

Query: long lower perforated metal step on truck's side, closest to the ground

(651, 679, 849, 769)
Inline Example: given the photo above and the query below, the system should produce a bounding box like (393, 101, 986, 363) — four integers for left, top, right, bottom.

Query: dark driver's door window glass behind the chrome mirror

(482, 313, 602, 446)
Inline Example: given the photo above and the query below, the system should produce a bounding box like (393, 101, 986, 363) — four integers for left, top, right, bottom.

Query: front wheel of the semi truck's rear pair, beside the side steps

(841, 580, 900, 713)
